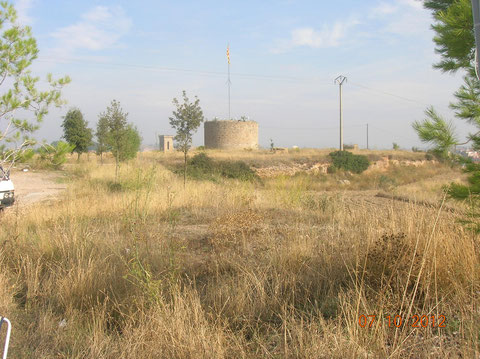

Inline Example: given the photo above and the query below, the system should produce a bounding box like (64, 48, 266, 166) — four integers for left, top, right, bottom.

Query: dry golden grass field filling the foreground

(0, 150, 480, 359)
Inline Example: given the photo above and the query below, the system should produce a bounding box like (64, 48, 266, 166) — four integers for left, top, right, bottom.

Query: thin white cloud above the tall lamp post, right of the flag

(272, 19, 358, 53)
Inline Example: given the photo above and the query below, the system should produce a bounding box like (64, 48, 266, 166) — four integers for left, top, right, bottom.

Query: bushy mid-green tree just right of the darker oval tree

(100, 100, 141, 182)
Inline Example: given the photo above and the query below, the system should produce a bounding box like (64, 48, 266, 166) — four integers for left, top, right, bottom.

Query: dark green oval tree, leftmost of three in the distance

(62, 108, 93, 161)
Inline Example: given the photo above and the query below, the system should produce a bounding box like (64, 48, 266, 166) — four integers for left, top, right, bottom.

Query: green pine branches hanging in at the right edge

(413, 0, 480, 155)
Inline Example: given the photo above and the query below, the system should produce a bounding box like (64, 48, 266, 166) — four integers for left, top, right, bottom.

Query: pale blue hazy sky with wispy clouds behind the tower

(14, 0, 473, 149)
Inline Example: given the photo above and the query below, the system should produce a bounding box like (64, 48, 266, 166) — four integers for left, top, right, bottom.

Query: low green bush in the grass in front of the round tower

(187, 152, 258, 181)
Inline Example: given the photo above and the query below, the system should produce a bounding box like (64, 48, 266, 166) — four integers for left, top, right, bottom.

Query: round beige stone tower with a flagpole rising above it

(204, 120, 258, 150)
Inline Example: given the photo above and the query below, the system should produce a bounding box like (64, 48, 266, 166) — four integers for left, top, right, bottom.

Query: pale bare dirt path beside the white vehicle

(10, 171, 67, 207)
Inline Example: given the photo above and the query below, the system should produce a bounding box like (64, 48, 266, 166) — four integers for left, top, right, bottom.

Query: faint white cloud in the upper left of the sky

(51, 6, 132, 54)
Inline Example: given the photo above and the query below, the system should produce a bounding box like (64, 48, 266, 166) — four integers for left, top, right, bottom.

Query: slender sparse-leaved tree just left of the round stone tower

(169, 91, 204, 186)
